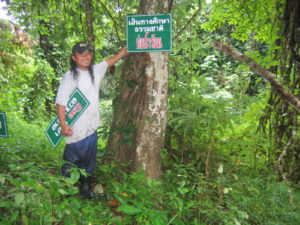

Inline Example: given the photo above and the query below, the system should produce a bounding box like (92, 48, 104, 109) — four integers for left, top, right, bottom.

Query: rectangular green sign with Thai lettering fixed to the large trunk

(126, 14, 172, 52)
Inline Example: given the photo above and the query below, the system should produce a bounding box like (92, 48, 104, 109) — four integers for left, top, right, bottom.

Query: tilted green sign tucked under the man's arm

(45, 88, 90, 148)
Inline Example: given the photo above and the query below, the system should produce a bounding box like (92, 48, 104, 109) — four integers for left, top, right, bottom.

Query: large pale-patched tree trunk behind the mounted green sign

(108, 0, 168, 179)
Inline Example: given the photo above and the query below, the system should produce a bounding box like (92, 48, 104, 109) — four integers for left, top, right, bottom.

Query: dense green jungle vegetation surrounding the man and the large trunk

(0, 0, 300, 225)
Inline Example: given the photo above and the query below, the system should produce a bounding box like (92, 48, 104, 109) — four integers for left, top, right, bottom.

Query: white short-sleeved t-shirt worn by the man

(55, 61, 108, 144)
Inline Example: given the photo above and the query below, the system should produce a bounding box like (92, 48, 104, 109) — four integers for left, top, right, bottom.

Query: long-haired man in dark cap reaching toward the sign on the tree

(55, 42, 127, 198)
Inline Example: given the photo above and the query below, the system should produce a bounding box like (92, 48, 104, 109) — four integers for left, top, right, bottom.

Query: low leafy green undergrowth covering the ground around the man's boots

(0, 117, 300, 225)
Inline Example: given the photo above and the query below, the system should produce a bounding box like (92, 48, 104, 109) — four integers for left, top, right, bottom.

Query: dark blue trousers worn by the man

(61, 132, 98, 177)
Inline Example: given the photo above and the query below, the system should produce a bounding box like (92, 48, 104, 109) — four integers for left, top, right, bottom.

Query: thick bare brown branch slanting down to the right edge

(212, 42, 300, 112)
